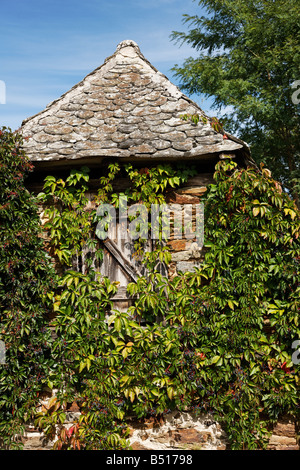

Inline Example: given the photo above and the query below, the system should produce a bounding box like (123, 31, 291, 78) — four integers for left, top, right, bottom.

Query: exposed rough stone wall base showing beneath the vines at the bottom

(22, 396, 300, 451)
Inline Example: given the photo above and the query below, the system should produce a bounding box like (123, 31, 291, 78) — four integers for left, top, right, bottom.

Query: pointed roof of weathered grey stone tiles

(21, 41, 245, 163)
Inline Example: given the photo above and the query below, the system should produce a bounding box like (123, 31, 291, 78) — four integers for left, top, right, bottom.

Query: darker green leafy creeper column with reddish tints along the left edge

(0, 128, 54, 448)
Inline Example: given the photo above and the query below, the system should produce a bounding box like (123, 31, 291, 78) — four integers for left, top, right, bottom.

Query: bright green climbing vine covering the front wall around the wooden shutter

(0, 126, 300, 450)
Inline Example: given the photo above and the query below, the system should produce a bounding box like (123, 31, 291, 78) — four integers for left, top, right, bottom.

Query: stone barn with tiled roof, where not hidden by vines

(21, 40, 251, 309)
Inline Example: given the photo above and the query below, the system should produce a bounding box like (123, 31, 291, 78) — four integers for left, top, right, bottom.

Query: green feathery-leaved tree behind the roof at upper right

(172, 0, 300, 207)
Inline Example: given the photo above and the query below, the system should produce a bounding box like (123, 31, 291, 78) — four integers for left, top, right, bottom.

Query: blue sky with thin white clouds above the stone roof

(0, 0, 213, 130)
